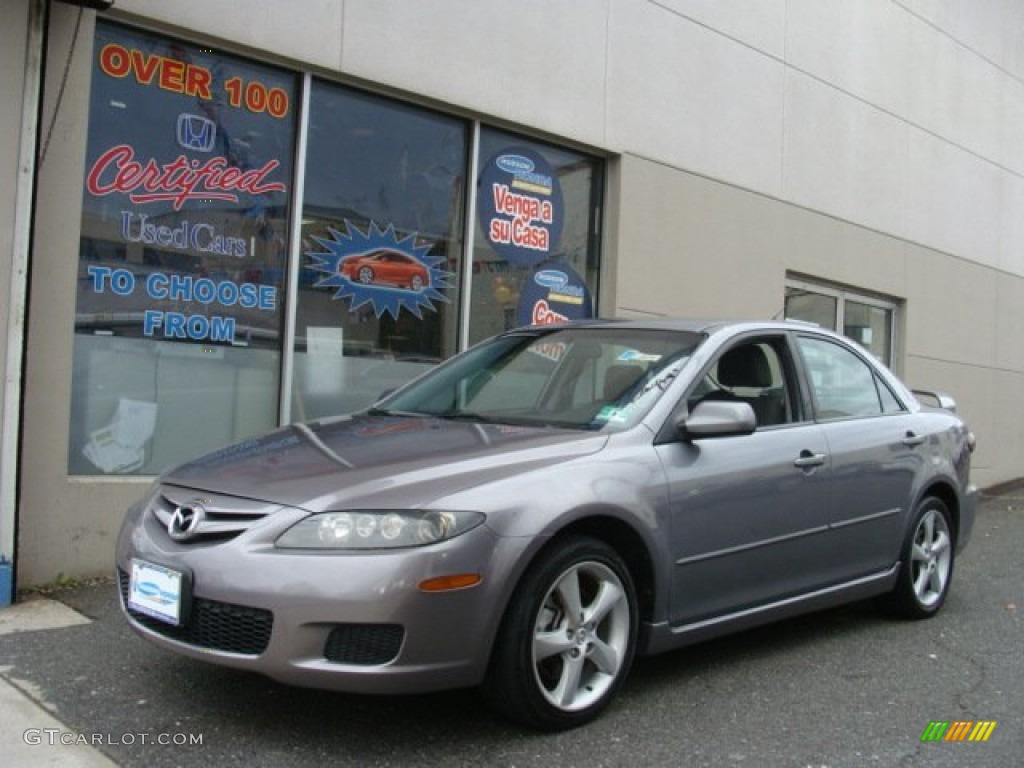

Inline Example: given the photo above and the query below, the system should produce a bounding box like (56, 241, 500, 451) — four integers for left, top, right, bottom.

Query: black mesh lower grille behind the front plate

(118, 568, 273, 655)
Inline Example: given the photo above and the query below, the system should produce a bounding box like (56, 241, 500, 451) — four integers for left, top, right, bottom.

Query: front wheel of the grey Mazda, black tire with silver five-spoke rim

(483, 538, 638, 730)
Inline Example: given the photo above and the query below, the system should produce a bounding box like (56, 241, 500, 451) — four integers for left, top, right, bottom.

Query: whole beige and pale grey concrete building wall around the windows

(18, 0, 1024, 583)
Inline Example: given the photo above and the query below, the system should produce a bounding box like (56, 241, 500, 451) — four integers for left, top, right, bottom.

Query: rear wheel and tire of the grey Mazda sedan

(880, 497, 956, 620)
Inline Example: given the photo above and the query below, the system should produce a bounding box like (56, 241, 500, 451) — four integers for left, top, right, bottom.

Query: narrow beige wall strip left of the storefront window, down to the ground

(18, 3, 109, 584)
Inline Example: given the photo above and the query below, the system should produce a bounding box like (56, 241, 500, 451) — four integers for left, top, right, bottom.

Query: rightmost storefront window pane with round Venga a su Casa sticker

(469, 128, 604, 343)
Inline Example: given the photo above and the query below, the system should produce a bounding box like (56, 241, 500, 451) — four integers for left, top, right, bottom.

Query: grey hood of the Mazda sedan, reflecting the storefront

(162, 415, 607, 512)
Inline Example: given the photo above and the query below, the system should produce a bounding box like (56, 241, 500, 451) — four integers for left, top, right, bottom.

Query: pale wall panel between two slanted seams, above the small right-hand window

(782, 71, 908, 240)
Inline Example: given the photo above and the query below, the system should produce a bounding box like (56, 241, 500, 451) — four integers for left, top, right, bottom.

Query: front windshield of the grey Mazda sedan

(371, 328, 702, 429)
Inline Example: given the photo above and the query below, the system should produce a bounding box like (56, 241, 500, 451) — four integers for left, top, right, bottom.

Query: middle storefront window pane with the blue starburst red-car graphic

(291, 81, 467, 421)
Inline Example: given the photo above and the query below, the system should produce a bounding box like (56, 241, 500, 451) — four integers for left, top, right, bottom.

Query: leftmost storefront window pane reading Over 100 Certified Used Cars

(68, 20, 296, 474)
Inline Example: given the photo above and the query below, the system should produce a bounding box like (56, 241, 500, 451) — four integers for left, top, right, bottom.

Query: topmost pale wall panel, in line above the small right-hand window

(785, 0, 911, 121)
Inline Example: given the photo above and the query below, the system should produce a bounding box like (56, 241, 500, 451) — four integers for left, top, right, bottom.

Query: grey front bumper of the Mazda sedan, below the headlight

(117, 493, 525, 693)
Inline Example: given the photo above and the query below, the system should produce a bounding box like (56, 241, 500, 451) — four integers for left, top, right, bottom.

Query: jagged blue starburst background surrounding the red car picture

(306, 221, 452, 319)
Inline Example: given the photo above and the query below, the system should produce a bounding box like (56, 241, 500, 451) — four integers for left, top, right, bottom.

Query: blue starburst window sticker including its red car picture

(306, 220, 452, 319)
